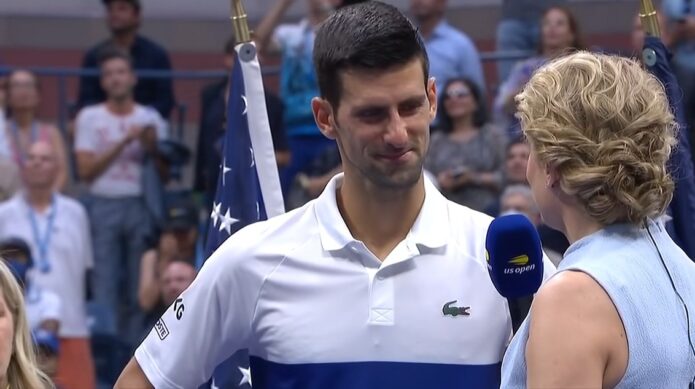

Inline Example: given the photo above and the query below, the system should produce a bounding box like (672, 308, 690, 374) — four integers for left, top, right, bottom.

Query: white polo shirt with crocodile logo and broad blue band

(135, 175, 554, 389)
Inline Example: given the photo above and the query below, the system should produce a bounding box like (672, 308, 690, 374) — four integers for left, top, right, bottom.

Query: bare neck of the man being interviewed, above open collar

(336, 177, 425, 261)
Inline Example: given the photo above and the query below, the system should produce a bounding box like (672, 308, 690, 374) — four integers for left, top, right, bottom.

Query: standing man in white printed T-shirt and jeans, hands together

(75, 51, 167, 348)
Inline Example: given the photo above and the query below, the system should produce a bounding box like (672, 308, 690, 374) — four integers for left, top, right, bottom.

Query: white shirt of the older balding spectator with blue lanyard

(0, 192, 93, 338)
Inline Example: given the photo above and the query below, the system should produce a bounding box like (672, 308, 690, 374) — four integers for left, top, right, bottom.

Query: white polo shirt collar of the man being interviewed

(314, 173, 450, 251)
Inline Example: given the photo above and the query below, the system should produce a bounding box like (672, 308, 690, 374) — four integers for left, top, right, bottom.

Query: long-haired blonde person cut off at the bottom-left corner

(0, 261, 50, 389)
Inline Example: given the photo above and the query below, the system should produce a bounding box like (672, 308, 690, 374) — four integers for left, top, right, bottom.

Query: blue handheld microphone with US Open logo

(485, 214, 543, 333)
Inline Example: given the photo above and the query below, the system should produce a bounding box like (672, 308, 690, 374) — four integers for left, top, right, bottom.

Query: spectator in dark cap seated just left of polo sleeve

(138, 200, 198, 330)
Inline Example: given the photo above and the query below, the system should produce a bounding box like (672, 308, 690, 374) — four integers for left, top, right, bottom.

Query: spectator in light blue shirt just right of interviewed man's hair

(410, 0, 485, 95)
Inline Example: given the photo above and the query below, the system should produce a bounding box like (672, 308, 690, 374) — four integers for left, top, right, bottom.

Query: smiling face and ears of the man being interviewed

(323, 58, 437, 189)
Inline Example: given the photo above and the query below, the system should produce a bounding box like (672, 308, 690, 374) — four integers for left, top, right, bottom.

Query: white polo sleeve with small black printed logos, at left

(135, 230, 263, 388)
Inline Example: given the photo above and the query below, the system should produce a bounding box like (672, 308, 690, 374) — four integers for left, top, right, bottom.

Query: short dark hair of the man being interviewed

(314, 1, 429, 108)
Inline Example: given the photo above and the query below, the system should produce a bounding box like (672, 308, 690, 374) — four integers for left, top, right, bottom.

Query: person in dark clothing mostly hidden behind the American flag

(194, 38, 290, 207)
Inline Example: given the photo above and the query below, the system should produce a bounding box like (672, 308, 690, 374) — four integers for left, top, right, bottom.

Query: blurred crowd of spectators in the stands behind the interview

(0, 0, 695, 388)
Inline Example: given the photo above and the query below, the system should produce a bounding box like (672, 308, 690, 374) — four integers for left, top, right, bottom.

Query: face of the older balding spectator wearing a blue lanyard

(22, 141, 58, 190)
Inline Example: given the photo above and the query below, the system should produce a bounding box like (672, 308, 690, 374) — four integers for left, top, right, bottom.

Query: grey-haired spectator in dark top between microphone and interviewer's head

(500, 184, 569, 266)
